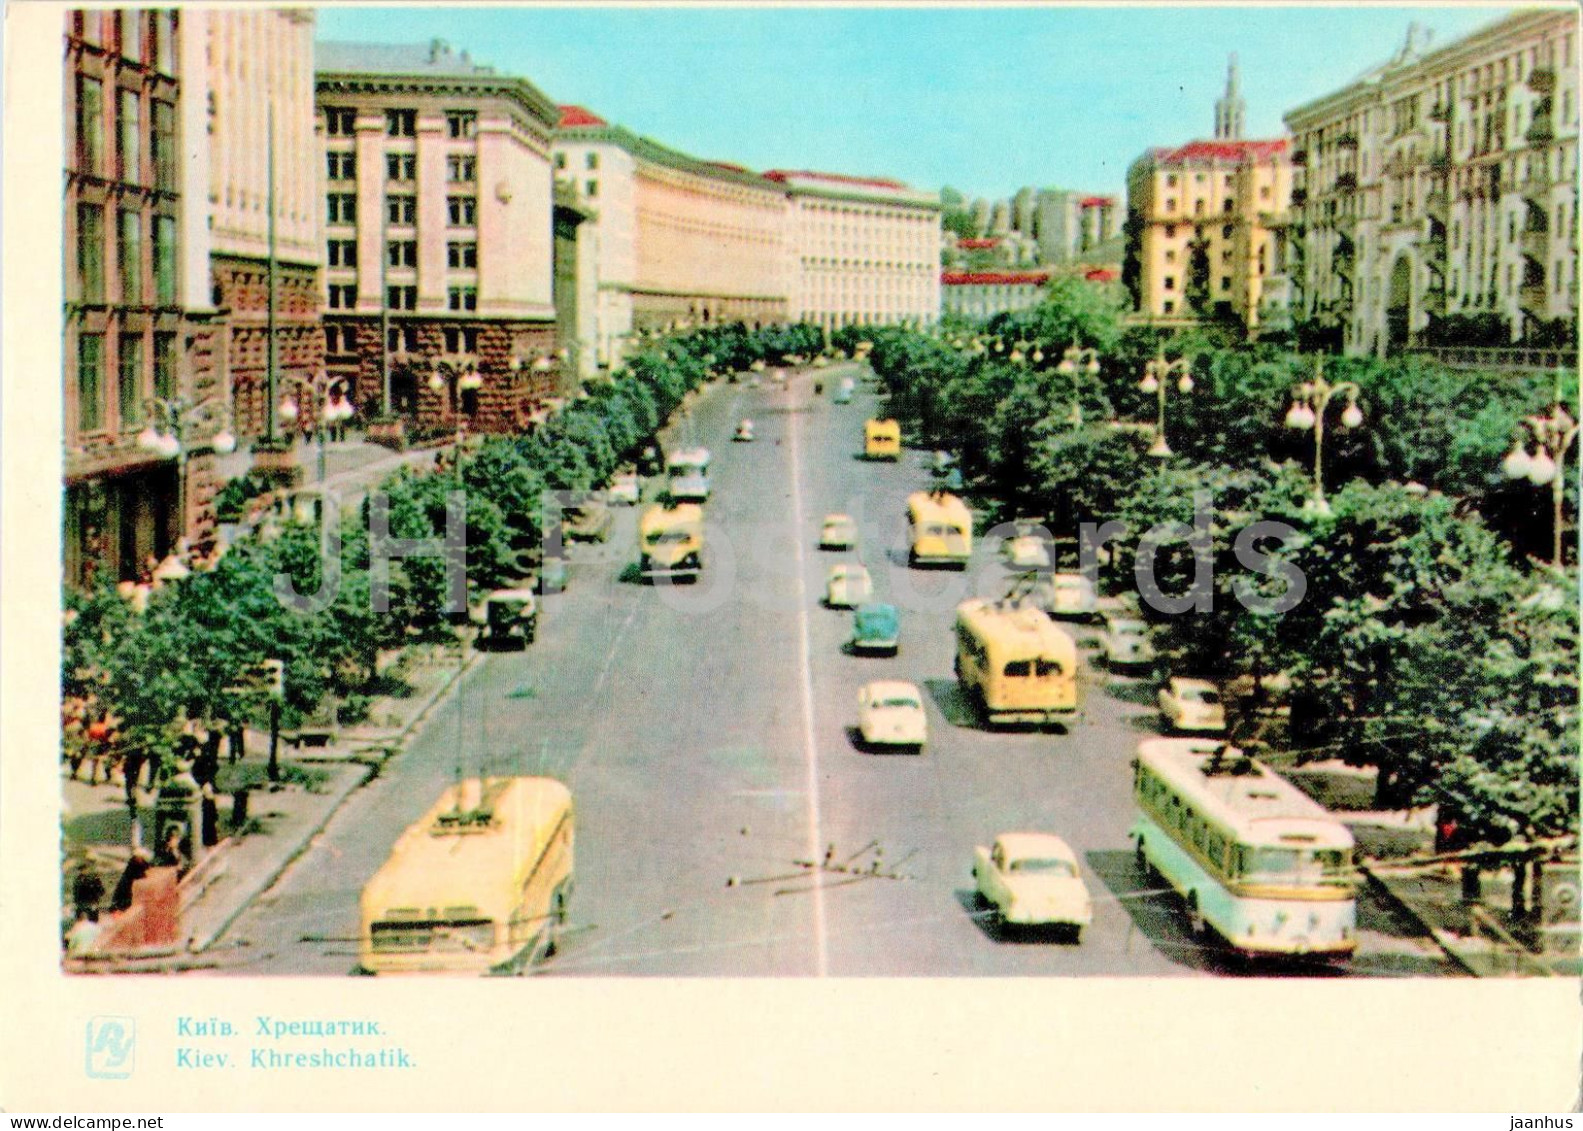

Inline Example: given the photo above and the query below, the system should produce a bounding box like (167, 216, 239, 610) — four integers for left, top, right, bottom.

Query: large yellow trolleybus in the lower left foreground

(359, 778, 573, 974)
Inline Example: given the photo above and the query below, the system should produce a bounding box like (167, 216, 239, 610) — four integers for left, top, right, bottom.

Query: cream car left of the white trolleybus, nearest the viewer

(974, 833, 1094, 943)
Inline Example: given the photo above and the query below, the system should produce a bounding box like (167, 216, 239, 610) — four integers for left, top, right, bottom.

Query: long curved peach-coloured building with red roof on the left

(556, 106, 787, 366)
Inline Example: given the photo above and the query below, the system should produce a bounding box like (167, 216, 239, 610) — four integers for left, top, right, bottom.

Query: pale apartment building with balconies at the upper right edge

(1285, 10, 1578, 353)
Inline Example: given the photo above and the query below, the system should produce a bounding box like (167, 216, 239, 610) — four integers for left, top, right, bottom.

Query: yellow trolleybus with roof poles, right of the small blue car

(956, 599, 1078, 725)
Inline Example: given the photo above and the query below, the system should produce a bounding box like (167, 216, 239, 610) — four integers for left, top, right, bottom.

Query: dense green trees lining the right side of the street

(836, 299, 1578, 843)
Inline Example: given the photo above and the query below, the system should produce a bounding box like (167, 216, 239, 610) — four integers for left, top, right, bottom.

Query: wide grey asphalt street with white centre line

(215, 369, 1453, 977)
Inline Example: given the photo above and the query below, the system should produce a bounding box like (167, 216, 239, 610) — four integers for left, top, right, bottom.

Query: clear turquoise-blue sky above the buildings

(318, 5, 1509, 196)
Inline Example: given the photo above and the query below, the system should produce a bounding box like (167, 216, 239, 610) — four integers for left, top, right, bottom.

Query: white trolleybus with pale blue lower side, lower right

(1130, 738, 1358, 958)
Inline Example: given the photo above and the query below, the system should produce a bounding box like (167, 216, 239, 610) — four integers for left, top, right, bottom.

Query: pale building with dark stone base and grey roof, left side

(315, 40, 564, 431)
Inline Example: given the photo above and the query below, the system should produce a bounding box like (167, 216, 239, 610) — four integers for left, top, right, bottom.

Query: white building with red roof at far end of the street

(763, 169, 940, 329)
